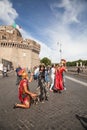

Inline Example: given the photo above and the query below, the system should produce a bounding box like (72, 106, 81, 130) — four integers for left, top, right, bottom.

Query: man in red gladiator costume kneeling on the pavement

(13, 71, 37, 108)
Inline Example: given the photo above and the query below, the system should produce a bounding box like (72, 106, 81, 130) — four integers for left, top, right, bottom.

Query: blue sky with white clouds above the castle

(0, 0, 87, 63)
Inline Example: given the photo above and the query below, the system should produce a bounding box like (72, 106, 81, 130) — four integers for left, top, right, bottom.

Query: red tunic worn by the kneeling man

(19, 79, 29, 103)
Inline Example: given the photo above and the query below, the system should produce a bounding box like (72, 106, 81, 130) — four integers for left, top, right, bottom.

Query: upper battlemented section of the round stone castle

(0, 26, 40, 53)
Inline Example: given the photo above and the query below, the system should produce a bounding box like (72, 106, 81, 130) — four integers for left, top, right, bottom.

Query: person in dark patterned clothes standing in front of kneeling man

(38, 65, 48, 102)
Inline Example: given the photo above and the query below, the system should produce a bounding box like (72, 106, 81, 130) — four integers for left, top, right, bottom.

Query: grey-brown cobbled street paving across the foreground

(0, 74, 87, 130)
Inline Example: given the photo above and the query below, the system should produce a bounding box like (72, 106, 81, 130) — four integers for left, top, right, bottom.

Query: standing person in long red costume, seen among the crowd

(54, 64, 66, 93)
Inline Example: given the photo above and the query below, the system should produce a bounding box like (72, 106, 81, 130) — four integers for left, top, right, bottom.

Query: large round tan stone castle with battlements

(0, 26, 40, 69)
